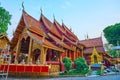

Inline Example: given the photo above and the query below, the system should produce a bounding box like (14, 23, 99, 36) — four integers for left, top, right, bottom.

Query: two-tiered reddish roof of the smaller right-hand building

(79, 37, 105, 53)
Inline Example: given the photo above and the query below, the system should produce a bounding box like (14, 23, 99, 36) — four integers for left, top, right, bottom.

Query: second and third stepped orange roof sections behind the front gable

(40, 14, 79, 50)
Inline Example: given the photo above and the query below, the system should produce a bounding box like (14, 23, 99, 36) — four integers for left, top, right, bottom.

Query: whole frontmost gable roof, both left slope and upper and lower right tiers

(11, 11, 63, 52)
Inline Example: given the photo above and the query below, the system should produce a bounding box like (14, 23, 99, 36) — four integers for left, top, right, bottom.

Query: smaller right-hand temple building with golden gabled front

(79, 37, 115, 67)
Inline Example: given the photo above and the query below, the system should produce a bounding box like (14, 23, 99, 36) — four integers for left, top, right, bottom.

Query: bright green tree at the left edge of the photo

(0, 7, 11, 34)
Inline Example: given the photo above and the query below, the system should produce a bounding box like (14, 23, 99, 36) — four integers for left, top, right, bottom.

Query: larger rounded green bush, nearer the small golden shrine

(74, 58, 89, 72)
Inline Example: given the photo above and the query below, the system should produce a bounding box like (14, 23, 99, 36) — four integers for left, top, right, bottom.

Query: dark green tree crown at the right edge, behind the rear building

(103, 23, 120, 46)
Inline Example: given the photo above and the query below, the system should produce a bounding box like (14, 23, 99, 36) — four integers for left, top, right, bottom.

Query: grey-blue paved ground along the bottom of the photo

(8, 74, 120, 80)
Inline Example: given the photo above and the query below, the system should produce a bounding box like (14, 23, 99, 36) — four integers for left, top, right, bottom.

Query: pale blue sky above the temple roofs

(0, 0, 120, 43)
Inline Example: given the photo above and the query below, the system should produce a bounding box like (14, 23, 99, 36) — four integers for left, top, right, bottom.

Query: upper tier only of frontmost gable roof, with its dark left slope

(11, 11, 44, 48)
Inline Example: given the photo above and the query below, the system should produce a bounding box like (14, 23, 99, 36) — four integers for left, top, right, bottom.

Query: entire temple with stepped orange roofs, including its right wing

(11, 10, 113, 72)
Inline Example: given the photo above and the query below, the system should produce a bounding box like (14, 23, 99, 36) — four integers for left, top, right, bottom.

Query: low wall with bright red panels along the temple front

(0, 64, 49, 77)
